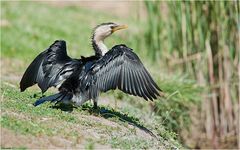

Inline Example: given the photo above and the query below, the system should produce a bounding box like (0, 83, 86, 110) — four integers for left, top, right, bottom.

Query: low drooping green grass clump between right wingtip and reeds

(154, 77, 202, 135)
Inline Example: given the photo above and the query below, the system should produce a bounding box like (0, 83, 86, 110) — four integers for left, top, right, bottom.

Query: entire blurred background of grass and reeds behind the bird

(1, 1, 240, 148)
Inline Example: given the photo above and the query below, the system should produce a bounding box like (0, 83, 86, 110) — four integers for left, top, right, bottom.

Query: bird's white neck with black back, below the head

(92, 34, 108, 57)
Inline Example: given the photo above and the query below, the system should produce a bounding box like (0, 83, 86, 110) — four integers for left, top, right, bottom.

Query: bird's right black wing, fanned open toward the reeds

(86, 45, 161, 100)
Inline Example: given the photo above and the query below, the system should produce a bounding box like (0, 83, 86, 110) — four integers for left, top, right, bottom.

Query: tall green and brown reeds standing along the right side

(140, 1, 240, 148)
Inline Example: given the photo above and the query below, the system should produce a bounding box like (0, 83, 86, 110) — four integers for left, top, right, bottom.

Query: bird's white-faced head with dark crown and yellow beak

(93, 22, 127, 42)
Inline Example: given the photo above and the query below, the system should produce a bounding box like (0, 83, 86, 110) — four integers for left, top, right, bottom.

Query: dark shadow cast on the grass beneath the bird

(52, 104, 157, 138)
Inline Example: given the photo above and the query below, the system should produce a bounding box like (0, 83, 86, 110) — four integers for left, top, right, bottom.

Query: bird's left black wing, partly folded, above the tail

(20, 40, 80, 93)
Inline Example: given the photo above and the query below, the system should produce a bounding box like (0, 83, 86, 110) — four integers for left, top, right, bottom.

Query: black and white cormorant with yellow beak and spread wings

(20, 22, 162, 108)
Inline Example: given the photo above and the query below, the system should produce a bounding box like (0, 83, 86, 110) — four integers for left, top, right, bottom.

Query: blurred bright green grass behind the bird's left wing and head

(1, 2, 137, 60)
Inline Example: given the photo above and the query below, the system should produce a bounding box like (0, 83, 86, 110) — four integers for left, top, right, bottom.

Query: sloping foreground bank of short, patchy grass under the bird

(1, 82, 180, 149)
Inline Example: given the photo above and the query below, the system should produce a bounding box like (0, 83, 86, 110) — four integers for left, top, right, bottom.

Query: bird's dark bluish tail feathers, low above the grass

(33, 92, 72, 106)
